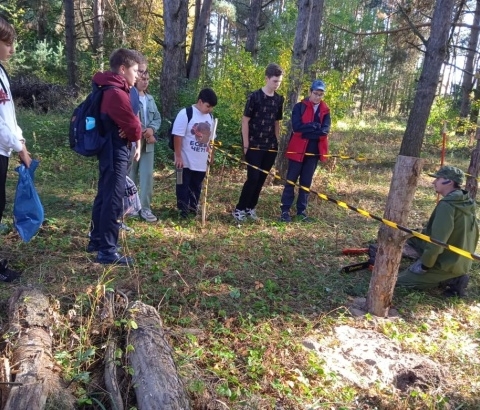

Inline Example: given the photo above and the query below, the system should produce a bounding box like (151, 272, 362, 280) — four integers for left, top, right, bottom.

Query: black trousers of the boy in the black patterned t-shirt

(236, 149, 277, 211)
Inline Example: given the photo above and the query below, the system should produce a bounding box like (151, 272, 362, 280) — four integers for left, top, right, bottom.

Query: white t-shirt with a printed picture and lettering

(172, 105, 213, 172)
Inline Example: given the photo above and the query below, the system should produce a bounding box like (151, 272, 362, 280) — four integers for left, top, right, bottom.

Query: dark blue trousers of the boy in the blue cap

(280, 155, 318, 214)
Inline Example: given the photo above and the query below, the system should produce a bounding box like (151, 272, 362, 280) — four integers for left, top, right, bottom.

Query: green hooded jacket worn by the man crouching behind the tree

(420, 189, 478, 275)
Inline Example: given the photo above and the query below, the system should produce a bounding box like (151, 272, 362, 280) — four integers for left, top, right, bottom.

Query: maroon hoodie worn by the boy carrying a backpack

(93, 71, 142, 142)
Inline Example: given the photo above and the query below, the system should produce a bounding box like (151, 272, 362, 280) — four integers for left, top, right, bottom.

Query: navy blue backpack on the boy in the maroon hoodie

(68, 83, 115, 157)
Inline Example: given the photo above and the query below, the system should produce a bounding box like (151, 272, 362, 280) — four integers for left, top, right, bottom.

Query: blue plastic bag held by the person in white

(13, 159, 44, 242)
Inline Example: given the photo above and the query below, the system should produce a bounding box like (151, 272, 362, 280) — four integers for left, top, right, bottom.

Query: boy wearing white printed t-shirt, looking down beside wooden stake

(172, 88, 217, 218)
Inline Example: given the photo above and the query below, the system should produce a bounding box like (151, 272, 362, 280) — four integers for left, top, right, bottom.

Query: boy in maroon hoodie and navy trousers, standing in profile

(87, 48, 142, 265)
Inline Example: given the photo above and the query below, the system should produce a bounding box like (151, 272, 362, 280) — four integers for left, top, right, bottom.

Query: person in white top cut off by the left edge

(0, 17, 32, 234)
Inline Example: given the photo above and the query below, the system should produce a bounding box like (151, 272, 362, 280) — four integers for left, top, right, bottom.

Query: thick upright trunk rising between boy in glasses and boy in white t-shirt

(160, 0, 188, 118)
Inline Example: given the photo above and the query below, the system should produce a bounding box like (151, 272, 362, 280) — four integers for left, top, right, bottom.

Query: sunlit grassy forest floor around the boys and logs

(0, 112, 480, 410)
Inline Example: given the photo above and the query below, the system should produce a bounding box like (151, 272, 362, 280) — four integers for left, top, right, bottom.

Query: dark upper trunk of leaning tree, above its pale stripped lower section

(400, 0, 455, 157)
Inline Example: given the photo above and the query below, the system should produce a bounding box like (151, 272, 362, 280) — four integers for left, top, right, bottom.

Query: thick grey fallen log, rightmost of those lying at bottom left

(128, 302, 191, 410)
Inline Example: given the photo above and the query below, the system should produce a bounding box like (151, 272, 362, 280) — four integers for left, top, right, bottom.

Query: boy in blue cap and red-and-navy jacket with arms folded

(280, 80, 331, 222)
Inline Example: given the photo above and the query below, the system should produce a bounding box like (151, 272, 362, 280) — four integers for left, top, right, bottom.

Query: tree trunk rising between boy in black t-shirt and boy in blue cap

(275, 0, 314, 178)
